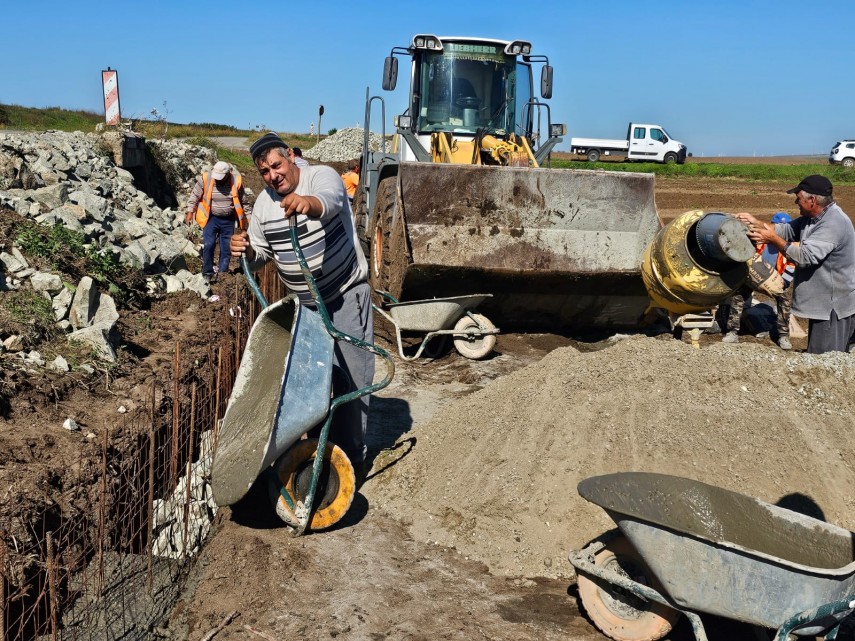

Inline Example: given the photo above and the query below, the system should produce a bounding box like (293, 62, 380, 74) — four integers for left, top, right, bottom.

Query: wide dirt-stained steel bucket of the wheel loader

(372, 163, 662, 331)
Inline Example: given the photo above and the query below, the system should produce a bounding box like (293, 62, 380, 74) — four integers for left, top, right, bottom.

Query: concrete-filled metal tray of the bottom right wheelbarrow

(578, 472, 855, 635)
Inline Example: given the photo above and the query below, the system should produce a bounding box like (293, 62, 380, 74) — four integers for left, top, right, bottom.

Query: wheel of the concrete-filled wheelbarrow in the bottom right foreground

(577, 535, 680, 641)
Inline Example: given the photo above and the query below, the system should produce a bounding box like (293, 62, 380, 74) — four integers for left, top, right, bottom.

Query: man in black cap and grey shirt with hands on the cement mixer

(737, 175, 855, 354)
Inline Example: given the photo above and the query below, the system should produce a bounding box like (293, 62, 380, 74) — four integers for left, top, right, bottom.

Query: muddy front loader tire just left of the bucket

(369, 176, 408, 300)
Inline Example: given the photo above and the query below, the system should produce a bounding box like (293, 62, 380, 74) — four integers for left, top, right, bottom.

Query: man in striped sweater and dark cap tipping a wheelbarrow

(231, 132, 374, 484)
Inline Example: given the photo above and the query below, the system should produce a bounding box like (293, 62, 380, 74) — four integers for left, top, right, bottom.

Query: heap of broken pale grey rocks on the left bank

(0, 131, 224, 360)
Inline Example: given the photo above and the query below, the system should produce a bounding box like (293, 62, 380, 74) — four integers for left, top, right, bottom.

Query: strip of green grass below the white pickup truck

(552, 159, 855, 185)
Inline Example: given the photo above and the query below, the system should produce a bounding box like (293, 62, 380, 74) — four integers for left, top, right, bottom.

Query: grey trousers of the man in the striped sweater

(309, 283, 374, 465)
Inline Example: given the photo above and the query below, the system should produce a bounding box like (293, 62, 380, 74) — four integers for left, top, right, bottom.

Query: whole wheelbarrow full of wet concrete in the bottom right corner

(570, 472, 855, 641)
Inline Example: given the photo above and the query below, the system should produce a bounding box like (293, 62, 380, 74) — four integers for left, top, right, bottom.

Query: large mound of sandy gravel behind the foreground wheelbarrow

(372, 336, 855, 577)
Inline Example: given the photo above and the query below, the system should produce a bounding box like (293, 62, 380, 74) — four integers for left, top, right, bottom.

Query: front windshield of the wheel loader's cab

(414, 43, 516, 133)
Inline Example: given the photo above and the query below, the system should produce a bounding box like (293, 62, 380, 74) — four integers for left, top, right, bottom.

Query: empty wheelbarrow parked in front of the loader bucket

(373, 289, 499, 361)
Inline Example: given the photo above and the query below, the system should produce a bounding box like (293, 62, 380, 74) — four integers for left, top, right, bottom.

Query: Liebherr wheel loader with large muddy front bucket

(353, 34, 744, 332)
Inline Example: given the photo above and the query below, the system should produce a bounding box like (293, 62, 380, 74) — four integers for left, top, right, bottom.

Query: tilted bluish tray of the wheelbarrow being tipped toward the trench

(211, 295, 335, 505)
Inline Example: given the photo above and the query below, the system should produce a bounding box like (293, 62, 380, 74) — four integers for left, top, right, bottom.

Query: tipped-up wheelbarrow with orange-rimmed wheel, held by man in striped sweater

(211, 217, 395, 535)
